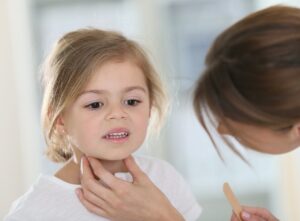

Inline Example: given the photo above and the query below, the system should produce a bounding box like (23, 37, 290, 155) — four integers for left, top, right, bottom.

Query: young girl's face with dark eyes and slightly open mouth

(62, 61, 150, 160)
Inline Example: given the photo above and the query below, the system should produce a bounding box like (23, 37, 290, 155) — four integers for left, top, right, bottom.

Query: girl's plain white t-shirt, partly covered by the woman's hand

(4, 157, 201, 221)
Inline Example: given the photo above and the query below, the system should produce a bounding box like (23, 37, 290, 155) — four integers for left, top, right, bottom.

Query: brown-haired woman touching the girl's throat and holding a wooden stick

(76, 6, 300, 221)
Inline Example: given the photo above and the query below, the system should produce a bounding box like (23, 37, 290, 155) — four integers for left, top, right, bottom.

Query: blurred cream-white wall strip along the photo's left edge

(0, 0, 40, 218)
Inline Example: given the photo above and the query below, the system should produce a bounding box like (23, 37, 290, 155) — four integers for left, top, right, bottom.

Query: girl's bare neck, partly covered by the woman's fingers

(54, 158, 128, 184)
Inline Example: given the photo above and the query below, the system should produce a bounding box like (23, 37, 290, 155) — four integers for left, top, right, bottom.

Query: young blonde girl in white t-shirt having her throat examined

(5, 29, 201, 221)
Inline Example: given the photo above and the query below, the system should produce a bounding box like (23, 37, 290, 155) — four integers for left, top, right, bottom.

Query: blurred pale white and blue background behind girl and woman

(0, 0, 300, 221)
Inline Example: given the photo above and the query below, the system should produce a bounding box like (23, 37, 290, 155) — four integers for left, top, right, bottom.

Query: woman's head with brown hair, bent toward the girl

(194, 6, 300, 153)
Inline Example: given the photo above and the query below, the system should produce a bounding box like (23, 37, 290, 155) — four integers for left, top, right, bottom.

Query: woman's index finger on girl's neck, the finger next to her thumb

(88, 157, 124, 190)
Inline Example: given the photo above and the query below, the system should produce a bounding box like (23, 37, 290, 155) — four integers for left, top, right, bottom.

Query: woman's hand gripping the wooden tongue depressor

(231, 207, 279, 221)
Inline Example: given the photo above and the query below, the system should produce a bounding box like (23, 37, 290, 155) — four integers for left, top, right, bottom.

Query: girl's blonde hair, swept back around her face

(41, 29, 167, 162)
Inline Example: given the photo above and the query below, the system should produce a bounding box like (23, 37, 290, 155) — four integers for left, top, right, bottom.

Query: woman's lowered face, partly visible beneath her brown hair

(217, 119, 300, 154)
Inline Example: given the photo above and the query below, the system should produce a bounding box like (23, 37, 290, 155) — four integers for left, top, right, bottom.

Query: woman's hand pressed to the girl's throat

(76, 156, 184, 221)
